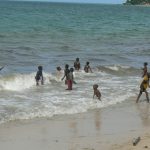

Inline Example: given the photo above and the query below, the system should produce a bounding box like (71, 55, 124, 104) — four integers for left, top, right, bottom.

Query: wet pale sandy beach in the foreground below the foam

(0, 100, 150, 150)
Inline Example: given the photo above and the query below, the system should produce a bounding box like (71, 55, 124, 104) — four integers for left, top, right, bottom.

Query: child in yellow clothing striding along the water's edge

(136, 73, 150, 103)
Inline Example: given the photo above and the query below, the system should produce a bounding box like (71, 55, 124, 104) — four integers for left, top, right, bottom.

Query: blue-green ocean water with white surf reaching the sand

(0, 1, 150, 123)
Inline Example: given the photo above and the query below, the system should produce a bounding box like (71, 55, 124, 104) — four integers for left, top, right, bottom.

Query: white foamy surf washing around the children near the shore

(0, 71, 140, 122)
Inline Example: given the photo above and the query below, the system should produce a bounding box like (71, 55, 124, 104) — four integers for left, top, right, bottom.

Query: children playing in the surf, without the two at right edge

(35, 58, 101, 100)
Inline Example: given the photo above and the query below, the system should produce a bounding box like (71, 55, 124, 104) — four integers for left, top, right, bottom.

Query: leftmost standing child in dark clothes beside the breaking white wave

(35, 66, 44, 86)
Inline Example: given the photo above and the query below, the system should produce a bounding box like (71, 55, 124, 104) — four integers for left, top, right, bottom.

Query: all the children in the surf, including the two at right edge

(35, 58, 150, 103)
